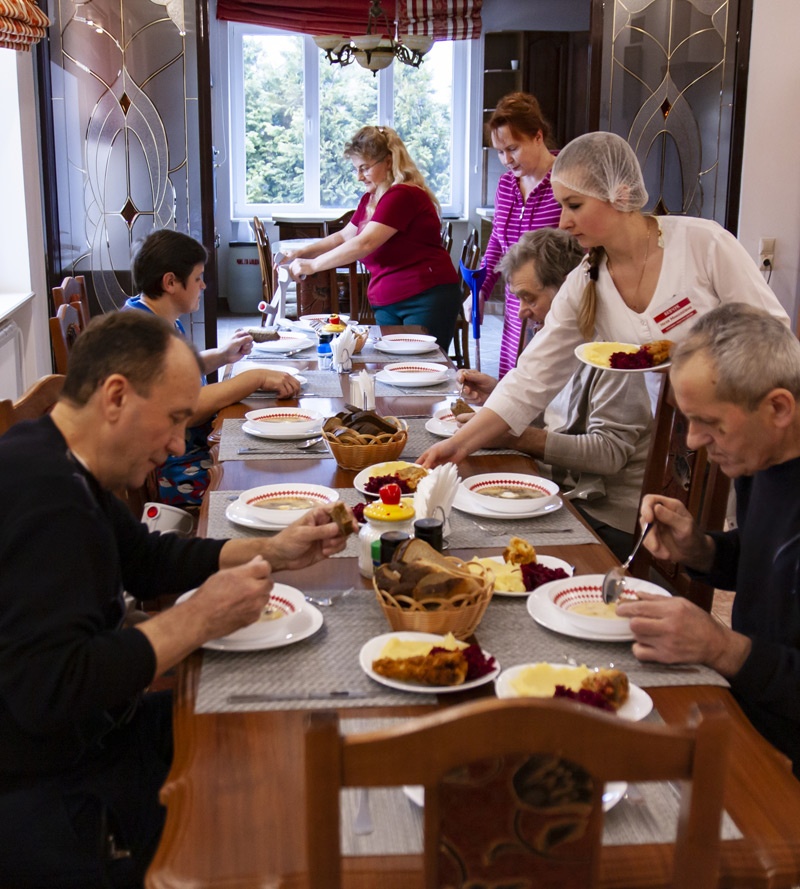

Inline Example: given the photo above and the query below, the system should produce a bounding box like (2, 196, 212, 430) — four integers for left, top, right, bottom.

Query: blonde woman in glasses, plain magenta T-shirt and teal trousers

(287, 127, 462, 352)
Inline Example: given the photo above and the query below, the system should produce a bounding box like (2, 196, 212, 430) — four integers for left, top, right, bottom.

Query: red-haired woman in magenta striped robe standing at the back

(481, 93, 561, 377)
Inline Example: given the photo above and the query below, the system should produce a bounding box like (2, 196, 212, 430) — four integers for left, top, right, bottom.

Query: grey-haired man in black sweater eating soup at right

(618, 303, 800, 776)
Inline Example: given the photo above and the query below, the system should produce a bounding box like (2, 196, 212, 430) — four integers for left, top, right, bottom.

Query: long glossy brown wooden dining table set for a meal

(146, 328, 800, 889)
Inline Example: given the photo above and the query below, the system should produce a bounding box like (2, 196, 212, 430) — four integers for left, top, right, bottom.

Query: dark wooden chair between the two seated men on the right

(631, 374, 730, 611)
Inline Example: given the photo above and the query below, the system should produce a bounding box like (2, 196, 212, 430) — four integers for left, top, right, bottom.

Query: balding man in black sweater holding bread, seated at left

(0, 312, 344, 889)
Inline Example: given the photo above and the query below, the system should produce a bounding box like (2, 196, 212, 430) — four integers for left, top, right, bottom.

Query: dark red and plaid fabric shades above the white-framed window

(217, 0, 482, 40)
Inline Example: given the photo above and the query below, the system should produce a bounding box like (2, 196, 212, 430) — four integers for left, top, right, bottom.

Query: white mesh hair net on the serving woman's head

(550, 133, 647, 213)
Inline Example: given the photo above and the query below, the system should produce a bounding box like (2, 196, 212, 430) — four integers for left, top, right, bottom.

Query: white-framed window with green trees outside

(230, 24, 468, 218)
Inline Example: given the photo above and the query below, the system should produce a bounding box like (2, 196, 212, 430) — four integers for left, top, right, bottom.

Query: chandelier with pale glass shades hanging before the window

(314, 0, 433, 74)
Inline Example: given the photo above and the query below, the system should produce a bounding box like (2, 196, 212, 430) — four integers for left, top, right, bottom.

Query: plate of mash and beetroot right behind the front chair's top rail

(495, 663, 653, 722)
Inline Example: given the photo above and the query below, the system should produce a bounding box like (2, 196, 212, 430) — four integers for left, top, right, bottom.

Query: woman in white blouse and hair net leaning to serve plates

(418, 133, 789, 468)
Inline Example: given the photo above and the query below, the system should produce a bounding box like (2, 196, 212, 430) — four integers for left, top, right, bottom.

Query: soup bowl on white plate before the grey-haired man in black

(527, 574, 670, 642)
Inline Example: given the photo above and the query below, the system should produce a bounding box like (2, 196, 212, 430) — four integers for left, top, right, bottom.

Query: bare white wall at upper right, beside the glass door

(739, 0, 800, 319)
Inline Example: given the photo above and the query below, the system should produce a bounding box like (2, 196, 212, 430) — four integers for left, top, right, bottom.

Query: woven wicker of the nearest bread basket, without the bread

(372, 556, 494, 639)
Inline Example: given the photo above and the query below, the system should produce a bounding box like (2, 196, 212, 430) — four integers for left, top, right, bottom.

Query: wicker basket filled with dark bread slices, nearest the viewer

(372, 539, 494, 639)
